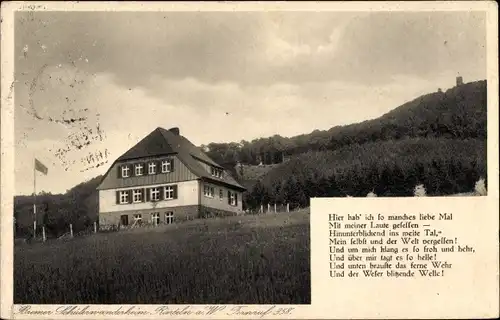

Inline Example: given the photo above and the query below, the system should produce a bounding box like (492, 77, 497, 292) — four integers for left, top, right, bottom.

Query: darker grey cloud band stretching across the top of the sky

(16, 12, 486, 87)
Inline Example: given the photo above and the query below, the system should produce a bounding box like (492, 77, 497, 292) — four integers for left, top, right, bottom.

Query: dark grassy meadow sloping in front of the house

(14, 211, 311, 304)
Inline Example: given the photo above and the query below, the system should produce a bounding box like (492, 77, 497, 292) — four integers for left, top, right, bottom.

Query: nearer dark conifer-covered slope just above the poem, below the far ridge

(246, 138, 486, 208)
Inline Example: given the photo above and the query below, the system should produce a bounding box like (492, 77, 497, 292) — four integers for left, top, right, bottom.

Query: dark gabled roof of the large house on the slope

(110, 127, 246, 190)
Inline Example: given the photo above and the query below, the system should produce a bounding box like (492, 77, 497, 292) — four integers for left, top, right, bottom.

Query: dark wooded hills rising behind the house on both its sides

(14, 80, 487, 235)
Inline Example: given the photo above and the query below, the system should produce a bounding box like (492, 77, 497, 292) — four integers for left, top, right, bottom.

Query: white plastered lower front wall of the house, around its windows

(99, 180, 199, 212)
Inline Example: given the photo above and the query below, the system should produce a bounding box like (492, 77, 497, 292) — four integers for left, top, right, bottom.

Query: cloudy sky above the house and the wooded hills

(14, 11, 486, 194)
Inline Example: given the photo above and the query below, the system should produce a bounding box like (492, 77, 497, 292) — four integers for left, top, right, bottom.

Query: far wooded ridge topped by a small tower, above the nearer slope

(205, 80, 487, 168)
